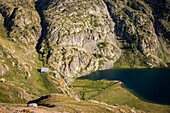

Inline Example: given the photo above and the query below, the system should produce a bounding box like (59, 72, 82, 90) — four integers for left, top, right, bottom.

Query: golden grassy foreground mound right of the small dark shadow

(27, 94, 142, 113)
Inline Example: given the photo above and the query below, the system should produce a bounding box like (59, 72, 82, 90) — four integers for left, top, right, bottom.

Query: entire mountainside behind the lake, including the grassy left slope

(0, 0, 170, 112)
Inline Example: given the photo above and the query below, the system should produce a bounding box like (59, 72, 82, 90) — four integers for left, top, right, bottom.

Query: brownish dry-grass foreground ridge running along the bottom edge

(0, 94, 144, 113)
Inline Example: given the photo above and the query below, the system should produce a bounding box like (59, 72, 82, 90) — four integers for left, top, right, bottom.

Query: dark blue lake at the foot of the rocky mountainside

(79, 68, 170, 105)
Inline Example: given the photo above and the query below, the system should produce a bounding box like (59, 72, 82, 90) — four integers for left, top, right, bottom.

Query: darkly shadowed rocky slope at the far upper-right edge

(145, 0, 170, 62)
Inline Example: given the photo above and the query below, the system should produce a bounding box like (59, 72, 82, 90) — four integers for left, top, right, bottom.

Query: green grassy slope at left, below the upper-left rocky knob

(0, 31, 58, 103)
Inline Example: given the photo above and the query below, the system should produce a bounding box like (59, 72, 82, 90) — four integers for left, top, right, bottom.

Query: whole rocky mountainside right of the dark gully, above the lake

(42, 0, 170, 77)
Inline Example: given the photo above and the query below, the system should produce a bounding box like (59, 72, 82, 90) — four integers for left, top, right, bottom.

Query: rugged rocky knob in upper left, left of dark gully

(0, 0, 41, 45)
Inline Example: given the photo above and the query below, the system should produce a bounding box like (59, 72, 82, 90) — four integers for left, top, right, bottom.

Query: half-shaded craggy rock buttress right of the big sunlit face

(105, 0, 169, 67)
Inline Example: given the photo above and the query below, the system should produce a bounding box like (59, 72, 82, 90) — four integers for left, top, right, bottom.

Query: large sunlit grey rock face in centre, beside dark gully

(45, 0, 121, 76)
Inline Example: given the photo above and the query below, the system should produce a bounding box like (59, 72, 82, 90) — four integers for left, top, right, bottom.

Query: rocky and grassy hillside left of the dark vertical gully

(0, 0, 58, 103)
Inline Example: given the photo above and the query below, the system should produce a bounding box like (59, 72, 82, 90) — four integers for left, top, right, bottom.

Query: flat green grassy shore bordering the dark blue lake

(72, 80, 170, 113)
